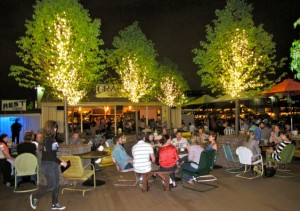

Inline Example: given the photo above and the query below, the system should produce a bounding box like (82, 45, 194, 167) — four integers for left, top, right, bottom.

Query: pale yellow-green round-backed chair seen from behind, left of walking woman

(14, 153, 39, 193)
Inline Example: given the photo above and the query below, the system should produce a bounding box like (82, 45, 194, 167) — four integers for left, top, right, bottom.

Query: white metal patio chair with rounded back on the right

(236, 146, 264, 179)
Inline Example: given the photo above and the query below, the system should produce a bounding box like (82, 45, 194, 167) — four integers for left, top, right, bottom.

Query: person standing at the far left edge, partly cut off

(0, 134, 14, 187)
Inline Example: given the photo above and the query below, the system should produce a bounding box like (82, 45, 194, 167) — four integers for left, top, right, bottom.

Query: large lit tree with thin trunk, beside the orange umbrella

(193, 0, 283, 131)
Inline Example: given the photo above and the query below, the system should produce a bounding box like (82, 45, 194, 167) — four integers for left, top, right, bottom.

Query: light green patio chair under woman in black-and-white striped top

(266, 144, 296, 177)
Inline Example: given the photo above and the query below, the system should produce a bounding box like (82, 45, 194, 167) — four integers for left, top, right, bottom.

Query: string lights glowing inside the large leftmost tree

(47, 13, 87, 105)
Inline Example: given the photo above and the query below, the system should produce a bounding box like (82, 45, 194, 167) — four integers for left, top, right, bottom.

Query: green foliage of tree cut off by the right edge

(291, 18, 300, 80)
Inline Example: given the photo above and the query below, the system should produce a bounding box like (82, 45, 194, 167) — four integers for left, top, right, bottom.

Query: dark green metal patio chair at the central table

(181, 150, 218, 192)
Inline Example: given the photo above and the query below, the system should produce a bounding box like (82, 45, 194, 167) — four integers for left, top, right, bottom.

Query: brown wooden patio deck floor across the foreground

(0, 159, 300, 211)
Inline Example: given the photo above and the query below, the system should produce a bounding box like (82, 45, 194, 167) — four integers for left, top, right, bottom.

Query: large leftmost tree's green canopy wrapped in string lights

(9, 0, 106, 105)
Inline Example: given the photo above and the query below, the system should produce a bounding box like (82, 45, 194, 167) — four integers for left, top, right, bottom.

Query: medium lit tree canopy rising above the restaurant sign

(108, 22, 157, 103)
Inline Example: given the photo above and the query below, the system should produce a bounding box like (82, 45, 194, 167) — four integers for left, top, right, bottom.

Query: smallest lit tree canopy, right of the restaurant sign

(156, 60, 188, 107)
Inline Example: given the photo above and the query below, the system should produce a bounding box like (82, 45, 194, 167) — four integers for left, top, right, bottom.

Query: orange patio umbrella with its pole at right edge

(263, 78, 300, 129)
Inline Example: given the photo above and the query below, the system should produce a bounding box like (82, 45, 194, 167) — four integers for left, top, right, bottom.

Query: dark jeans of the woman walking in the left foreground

(33, 160, 60, 204)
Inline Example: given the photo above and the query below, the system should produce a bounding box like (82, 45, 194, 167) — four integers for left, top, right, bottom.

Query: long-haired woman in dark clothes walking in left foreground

(30, 120, 67, 210)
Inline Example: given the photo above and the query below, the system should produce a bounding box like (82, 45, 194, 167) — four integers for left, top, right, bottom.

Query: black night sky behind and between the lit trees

(0, 0, 300, 100)
